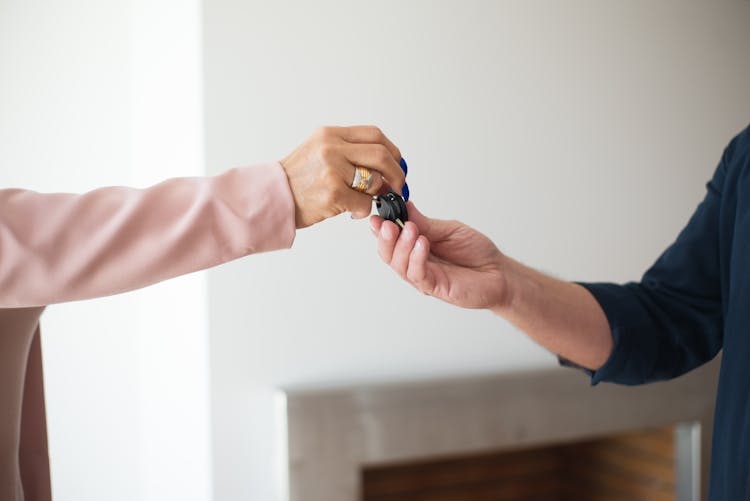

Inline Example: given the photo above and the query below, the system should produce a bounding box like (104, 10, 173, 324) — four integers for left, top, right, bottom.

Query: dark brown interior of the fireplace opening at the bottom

(362, 427, 675, 501)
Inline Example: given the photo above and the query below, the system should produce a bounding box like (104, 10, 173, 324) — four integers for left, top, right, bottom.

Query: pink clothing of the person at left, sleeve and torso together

(0, 163, 295, 501)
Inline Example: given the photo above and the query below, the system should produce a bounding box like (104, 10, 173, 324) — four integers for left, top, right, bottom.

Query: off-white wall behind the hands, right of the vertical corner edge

(204, 0, 750, 501)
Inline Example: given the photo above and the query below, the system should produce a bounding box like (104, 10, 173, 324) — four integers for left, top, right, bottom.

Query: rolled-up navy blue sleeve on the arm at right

(581, 138, 737, 384)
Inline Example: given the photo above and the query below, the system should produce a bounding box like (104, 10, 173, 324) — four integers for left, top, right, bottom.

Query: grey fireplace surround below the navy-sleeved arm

(283, 360, 719, 501)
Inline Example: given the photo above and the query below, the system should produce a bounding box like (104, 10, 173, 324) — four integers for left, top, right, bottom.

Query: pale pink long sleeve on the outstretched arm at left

(0, 163, 295, 308)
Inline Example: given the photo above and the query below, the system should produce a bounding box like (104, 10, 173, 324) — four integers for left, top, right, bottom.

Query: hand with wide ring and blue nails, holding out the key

(281, 126, 404, 228)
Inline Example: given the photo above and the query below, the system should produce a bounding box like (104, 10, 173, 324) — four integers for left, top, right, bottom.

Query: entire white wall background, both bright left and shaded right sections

(0, 0, 750, 501)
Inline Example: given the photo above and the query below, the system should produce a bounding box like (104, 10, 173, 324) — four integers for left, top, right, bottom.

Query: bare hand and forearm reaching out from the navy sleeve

(370, 202, 612, 370)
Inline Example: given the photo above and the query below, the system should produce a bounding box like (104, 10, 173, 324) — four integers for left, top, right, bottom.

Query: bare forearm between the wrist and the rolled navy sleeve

(493, 257, 613, 370)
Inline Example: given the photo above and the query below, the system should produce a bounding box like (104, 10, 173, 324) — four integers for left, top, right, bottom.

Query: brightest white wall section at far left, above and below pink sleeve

(0, 0, 211, 501)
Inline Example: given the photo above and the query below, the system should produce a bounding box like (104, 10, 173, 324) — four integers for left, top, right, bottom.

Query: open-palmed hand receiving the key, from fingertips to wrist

(370, 202, 506, 309)
